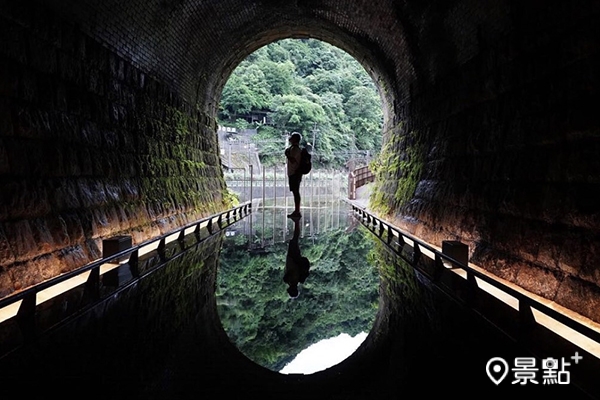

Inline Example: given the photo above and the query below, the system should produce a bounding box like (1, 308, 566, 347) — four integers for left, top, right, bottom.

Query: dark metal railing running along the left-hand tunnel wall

(0, 202, 252, 314)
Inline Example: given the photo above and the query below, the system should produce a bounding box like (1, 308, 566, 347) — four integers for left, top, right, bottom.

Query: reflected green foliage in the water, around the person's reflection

(217, 228, 379, 371)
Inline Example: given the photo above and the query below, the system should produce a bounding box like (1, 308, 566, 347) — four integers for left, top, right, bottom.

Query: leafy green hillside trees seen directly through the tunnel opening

(219, 39, 383, 167)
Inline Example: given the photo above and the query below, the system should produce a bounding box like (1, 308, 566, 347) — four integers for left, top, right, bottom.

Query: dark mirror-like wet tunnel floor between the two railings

(0, 206, 600, 399)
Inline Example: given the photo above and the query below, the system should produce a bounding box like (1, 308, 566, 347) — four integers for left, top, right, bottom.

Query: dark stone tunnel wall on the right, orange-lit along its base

(374, 1, 600, 322)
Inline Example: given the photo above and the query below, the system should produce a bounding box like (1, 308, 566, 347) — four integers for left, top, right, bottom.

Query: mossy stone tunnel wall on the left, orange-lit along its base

(0, 3, 226, 297)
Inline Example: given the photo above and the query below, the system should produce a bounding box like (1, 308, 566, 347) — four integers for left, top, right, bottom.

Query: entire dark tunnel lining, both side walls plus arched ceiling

(0, 0, 600, 321)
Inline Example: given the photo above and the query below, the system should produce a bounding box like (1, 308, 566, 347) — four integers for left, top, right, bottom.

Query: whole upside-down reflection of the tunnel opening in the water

(217, 208, 379, 373)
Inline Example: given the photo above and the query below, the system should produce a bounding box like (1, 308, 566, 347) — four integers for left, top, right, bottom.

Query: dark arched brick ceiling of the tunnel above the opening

(47, 0, 414, 120)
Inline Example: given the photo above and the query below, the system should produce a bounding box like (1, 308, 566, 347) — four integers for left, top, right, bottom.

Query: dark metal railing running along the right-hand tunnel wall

(350, 202, 600, 343)
